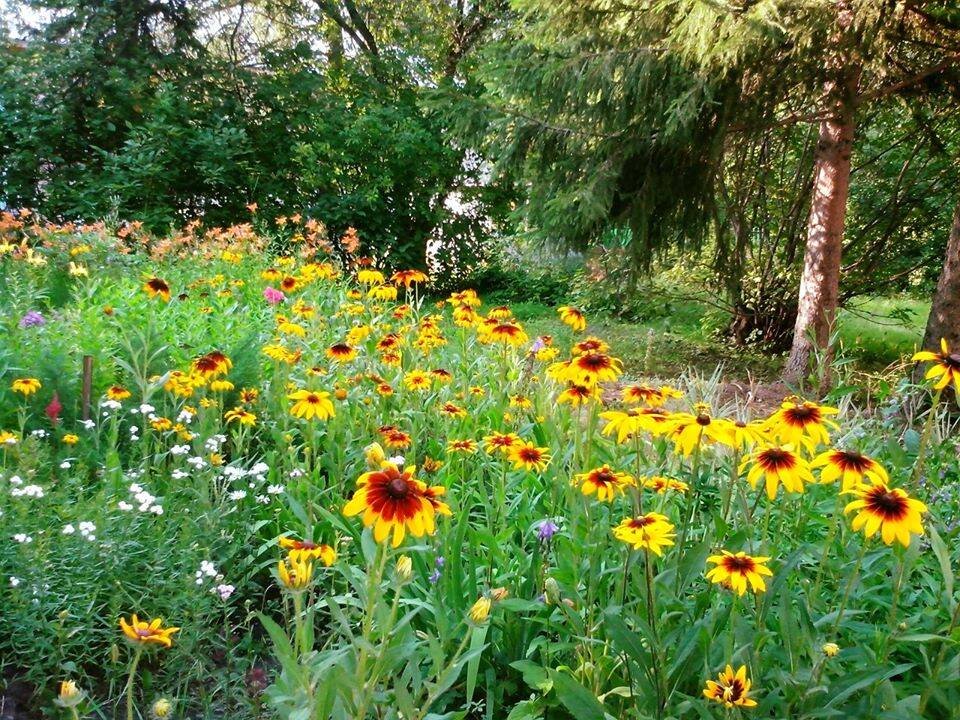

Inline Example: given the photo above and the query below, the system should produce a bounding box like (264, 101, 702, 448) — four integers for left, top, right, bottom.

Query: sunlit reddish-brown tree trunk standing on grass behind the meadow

(783, 66, 860, 384)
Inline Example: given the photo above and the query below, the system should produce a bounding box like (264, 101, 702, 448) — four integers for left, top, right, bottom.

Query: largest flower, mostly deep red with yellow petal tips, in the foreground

(343, 462, 451, 547)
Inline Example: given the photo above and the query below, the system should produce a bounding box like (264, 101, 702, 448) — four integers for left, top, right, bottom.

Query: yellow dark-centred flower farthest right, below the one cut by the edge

(843, 478, 927, 547)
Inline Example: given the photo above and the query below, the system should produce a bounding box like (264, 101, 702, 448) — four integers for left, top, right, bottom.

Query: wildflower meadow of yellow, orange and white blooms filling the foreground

(0, 211, 960, 720)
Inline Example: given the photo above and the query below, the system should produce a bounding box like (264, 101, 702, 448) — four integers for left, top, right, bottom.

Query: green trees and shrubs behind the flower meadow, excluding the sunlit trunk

(0, 0, 960, 375)
